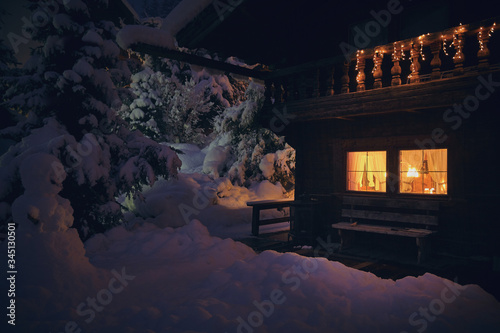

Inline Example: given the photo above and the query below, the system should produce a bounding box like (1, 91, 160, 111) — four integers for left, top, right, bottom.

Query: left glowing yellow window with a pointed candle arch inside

(347, 151, 387, 192)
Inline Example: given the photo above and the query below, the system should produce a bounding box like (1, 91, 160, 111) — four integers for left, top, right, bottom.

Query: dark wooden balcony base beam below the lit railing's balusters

(262, 67, 500, 123)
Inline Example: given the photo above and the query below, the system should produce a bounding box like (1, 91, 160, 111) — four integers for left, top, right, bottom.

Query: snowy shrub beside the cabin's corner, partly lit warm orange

(209, 82, 295, 190)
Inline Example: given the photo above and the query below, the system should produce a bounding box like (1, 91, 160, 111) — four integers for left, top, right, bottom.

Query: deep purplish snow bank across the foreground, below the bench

(4, 221, 500, 333)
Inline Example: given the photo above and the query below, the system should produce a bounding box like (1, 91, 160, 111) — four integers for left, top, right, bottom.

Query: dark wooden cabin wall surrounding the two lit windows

(287, 79, 500, 255)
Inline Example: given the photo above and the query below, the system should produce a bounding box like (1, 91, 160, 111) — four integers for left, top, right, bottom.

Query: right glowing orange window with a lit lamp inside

(399, 149, 448, 194)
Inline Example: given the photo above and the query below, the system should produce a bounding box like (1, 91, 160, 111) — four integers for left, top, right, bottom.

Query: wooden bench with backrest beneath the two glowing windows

(332, 196, 439, 263)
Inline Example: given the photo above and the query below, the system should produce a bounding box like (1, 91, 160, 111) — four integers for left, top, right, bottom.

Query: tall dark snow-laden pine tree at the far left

(0, 0, 181, 239)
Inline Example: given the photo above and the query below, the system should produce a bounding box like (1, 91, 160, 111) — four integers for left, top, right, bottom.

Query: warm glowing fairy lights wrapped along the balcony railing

(355, 22, 496, 82)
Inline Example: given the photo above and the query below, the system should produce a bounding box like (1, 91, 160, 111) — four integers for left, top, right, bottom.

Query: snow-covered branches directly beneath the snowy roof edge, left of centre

(120, 55, 248, 145)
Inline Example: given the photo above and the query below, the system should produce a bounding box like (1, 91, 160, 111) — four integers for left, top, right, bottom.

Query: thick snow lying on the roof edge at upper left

(116, 0, 212, 49)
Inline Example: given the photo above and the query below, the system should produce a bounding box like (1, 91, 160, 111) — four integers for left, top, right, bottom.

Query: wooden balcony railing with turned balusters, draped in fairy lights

(265, 19, 499, 105)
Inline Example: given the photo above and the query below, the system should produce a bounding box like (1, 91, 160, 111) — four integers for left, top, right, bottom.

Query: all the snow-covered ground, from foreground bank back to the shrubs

(1, 147, 500, 333)
